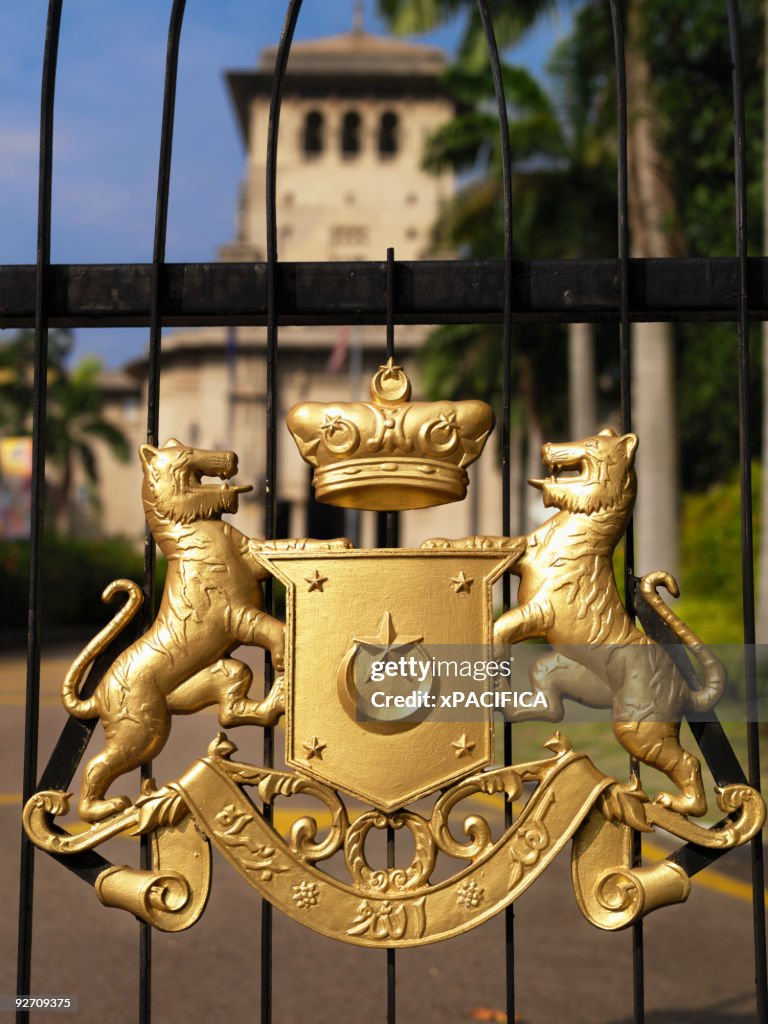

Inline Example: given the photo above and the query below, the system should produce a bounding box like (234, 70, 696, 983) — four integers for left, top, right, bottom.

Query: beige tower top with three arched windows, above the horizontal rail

(221, 25, 454, 260)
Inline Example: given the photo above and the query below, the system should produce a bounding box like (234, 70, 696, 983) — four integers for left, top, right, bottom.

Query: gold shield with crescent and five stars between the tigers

(259, 549, 518, 811)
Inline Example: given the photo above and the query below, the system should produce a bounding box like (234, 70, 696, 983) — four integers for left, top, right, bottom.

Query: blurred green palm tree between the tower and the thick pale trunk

(409, 33, 615, 530)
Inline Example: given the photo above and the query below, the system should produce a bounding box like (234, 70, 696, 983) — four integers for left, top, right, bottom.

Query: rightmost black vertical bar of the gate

(726, 0, 768, 1024)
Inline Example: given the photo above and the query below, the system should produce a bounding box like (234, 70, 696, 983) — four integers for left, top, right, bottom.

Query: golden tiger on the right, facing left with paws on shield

(425, 429, 726, 815)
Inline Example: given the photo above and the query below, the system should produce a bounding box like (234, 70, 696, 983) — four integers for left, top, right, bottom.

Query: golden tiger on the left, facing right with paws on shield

(61, 439, 351, 821)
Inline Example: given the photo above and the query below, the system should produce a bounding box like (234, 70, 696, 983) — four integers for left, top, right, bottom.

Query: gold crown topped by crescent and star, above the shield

(286, 358, 494, 512)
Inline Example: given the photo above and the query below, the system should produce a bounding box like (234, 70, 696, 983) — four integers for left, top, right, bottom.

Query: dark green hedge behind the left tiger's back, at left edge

(0, 535, 166, 631)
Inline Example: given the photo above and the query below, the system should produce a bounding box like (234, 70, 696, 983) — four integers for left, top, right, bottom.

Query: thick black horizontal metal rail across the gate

(0, 257, 768, 329)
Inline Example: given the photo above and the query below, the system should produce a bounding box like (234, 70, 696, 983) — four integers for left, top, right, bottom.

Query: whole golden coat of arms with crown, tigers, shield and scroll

(24, 359, 765, 947)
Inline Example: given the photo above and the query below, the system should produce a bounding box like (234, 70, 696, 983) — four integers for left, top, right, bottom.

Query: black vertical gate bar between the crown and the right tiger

(477, 0, 515, 1021)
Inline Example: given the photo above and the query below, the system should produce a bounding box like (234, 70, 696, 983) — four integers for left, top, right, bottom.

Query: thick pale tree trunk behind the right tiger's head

(627, 2, 679, 574)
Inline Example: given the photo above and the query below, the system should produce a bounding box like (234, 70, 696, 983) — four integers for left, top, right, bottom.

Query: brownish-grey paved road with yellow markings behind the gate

(0, 650, 756, 1024)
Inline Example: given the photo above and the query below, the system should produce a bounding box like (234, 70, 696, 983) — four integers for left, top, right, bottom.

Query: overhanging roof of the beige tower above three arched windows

(226, 27, 446, 144)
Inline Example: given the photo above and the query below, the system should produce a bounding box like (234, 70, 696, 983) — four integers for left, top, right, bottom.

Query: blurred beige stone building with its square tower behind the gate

(94, 24, 505, 546)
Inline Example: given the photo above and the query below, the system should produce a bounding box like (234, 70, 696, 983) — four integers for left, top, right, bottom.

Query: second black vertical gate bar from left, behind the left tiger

(138, 8, 186, 1024)
